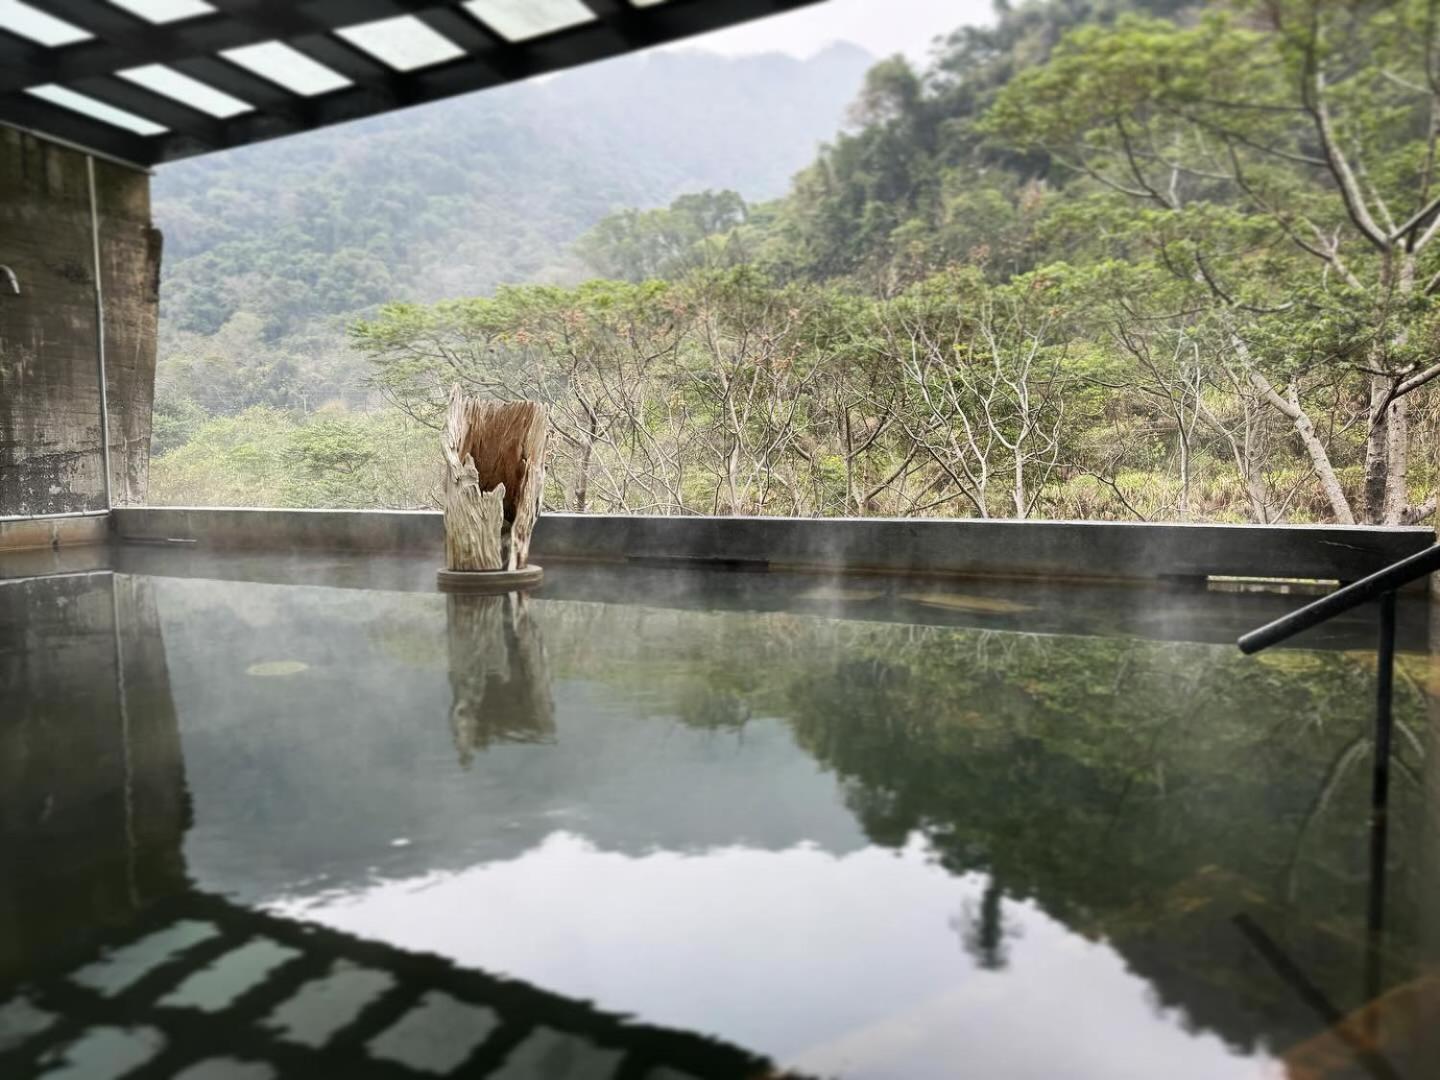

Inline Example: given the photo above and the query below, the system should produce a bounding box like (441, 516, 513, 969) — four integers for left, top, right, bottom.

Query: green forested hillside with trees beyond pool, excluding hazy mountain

(146, 0, 1440, 523)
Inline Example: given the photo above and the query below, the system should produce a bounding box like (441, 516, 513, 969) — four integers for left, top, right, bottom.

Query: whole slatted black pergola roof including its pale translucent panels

(0, 0, 816, 166)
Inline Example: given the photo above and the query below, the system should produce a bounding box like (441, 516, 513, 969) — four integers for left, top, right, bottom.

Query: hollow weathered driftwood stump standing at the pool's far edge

(444, 386, 549, 570)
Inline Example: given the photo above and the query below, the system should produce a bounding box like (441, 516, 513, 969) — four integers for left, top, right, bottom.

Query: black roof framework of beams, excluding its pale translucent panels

(0, 0, 818, 164)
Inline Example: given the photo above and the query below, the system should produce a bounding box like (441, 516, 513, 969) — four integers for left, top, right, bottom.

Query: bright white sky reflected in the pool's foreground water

(281, 831, 1273, 1080)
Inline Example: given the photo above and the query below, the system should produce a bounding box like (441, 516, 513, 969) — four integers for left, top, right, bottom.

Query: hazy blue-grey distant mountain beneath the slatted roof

(153, 45, 873, 338)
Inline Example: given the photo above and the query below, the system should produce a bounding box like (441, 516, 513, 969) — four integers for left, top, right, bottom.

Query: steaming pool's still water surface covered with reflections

(0, 575, 1440, 1080)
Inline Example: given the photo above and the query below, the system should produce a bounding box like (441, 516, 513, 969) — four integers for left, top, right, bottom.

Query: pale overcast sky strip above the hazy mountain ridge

(675, 0, 994, 60)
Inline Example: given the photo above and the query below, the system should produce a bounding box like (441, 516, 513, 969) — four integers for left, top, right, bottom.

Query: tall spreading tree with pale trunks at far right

(988, 0, 1440, 523)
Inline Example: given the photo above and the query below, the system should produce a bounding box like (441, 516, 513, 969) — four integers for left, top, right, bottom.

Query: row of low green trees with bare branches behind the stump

(353, 268, 1123, 516)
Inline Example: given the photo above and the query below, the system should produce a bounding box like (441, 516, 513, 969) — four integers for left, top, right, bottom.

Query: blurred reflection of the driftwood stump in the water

(445, 592, 554, 769)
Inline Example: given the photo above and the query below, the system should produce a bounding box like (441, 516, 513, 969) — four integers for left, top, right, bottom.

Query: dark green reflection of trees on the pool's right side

(532, 602, 1428, 1050)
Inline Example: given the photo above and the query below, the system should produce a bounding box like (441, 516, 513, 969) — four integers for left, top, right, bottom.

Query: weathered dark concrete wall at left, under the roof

(0, 127, 160, 516)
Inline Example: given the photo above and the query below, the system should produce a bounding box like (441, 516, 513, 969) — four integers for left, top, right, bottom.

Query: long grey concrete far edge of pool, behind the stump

(111, 507, 1436, 580)
